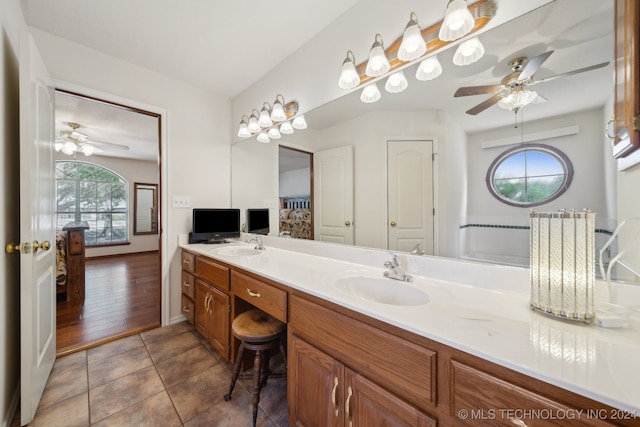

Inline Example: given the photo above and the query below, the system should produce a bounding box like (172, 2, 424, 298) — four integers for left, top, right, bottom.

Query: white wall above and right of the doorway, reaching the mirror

(32, 29, 230, 324)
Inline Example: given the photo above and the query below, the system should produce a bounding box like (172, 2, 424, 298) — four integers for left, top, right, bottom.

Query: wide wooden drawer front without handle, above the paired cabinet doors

(289, 295, 437, 410)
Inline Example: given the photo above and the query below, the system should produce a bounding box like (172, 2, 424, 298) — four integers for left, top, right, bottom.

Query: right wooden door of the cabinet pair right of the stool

(344, 368, 437, 427)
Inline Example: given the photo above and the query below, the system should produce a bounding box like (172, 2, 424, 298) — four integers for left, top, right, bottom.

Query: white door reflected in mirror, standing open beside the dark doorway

(313, 145, 353, 245)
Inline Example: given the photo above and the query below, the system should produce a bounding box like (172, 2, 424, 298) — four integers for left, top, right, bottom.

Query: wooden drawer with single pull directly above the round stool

(231, 271, 287, 323)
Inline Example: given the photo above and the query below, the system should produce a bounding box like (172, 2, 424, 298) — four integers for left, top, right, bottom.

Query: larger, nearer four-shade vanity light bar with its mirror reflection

(338, 0, 497, 103)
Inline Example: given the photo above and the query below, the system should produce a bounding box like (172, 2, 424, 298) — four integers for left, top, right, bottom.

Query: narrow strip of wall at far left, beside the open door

(0, 0, 26, 425)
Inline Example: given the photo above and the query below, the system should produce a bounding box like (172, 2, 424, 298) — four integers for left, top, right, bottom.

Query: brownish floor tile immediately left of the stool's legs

(168, 364, 232, 421)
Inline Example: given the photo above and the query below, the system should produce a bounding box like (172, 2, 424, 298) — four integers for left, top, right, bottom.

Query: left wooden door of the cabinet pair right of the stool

(287, 335, 344, 427)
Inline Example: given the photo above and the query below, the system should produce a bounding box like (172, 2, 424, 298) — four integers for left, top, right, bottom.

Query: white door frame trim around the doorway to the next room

(53, 79, 171, 326)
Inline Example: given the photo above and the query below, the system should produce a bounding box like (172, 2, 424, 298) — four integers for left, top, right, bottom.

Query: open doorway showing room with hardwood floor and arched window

(55, 89, 162, 356)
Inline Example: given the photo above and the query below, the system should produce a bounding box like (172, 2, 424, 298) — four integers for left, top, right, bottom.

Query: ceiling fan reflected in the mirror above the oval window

(453, 50, 609, 116)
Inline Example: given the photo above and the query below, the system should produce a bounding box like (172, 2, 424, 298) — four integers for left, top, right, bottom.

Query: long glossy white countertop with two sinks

(181, 238, 640, 417)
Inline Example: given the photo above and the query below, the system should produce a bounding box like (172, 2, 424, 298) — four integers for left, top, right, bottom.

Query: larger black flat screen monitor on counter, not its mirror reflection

(189, 208, 240, 243)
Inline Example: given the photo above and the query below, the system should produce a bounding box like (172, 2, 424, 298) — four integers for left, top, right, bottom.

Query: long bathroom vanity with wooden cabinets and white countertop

(182, 238, 640, 426)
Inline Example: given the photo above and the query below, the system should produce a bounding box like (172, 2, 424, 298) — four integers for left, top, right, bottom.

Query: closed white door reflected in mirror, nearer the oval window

(387, 141, 434, 255)
